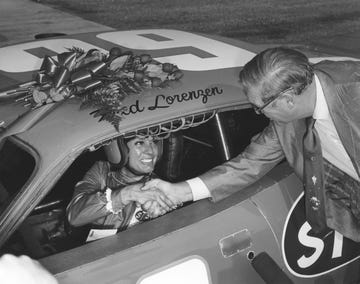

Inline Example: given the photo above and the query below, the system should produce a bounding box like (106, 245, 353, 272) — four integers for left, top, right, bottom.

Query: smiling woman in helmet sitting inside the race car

(67, 136, 175, 235)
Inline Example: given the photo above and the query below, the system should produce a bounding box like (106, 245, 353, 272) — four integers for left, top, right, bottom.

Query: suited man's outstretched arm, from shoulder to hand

(143, 122, 285, 206)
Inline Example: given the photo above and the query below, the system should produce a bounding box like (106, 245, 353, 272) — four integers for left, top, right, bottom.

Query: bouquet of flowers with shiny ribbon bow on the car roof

(11, 47, 183, 130)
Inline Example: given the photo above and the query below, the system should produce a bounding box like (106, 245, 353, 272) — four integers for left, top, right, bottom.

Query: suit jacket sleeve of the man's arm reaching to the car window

(200, 121, 285, 202)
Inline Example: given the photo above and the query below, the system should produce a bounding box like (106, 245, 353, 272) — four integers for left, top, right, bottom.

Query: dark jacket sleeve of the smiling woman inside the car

(67, 162, 123, 226)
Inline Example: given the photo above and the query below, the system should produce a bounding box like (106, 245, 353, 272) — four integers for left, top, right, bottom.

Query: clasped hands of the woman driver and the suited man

(121, 179, 193, 218)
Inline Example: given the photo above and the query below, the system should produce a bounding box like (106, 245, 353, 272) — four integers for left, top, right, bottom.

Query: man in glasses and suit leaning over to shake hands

(144, 47, 360, 242)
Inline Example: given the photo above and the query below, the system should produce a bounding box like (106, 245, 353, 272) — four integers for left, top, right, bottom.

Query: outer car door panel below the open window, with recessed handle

(49, 191, 280, 283)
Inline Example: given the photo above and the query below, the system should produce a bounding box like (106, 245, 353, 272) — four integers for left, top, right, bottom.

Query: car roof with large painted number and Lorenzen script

(0, 29, 358, 154)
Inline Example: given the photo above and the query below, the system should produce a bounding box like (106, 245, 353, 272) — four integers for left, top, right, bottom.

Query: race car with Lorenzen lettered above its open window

(0, 29, 360, 284)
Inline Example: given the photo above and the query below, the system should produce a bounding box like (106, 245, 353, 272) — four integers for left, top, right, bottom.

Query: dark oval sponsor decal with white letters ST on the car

(282, 193, 360, 278)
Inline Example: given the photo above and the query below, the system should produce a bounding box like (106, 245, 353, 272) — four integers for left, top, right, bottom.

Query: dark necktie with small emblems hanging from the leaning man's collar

(303, 117, 326, 233)
